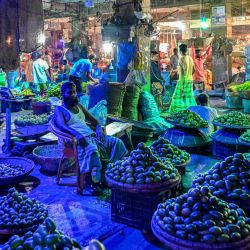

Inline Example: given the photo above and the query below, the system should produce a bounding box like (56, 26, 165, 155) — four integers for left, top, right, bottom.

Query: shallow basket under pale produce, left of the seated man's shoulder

(15, 124, 49, 139)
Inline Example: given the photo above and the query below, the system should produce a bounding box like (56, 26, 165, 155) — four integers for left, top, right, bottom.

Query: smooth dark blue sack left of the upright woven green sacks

(87, 79, 109, 108)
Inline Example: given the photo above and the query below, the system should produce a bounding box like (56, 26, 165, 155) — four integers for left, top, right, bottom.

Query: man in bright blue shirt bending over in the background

(69, 55, 97, 94)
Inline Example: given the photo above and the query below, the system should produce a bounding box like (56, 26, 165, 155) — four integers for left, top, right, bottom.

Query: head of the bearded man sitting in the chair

(61, 82, 79, 108)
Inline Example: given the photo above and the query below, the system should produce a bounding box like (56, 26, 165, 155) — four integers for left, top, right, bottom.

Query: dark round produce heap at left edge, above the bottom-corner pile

(0, 188, 48, 229)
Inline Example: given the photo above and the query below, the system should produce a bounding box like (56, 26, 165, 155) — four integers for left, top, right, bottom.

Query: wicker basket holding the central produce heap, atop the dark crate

(105, 175, 181, 194)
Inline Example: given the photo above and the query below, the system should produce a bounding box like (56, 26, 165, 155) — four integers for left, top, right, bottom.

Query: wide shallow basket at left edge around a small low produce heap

(0, 157, 35, 187)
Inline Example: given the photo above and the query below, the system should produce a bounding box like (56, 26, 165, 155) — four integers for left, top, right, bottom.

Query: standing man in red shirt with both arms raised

(191, 44, 212, 93)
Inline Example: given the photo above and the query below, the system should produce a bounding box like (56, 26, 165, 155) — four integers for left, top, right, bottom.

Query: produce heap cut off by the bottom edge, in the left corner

(1, 218, 82, 250)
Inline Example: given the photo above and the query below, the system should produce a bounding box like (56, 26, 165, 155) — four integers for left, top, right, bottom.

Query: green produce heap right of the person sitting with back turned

(214, 111, 250, 127)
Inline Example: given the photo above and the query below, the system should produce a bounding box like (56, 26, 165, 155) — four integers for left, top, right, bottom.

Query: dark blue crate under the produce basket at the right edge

(213, 141, 249, 160)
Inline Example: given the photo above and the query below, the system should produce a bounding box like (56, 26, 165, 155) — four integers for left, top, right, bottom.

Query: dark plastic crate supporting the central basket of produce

(111, 185, 181, 229)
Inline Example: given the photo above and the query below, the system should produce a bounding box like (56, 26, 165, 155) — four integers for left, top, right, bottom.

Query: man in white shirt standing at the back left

(31, 51, 50, 93)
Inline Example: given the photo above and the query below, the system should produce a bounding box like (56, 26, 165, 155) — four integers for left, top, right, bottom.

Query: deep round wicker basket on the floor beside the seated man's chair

(32, 145, 74, 175)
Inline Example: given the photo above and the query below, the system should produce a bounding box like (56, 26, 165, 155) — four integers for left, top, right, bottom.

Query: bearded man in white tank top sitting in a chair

(54, 82, 127, 194)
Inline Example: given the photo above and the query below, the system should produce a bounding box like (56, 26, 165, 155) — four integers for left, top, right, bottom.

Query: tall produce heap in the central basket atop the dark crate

(106, 143, 180, 184)
